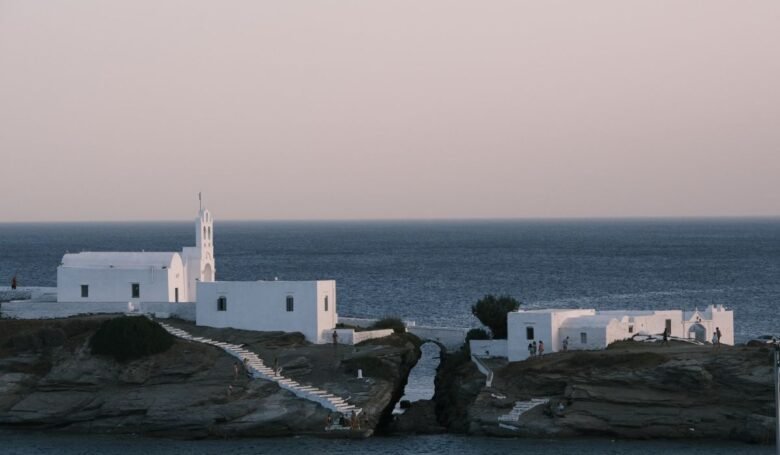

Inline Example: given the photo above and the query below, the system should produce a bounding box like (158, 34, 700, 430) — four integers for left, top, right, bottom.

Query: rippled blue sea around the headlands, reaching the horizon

(0, 218, 780, 454)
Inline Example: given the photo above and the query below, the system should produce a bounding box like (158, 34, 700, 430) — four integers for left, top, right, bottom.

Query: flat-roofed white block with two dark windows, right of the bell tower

(195, 280, 338, 343)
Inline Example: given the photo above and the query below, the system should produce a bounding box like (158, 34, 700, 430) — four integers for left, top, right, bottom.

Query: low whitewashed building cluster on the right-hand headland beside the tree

(507, 305, 734, 362)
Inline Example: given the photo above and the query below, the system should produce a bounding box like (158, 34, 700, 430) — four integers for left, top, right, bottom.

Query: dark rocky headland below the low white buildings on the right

(440, 343, 774, 442)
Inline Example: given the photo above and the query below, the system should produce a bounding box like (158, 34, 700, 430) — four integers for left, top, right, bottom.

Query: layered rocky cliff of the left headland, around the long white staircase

(0, 316, 419, 438)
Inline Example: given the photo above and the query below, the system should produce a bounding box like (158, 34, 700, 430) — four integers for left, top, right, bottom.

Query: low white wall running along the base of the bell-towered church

(0, 301, 195, 321)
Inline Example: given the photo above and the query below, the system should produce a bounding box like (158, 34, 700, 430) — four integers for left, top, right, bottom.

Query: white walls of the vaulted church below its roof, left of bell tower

(57, 262, 186, 303)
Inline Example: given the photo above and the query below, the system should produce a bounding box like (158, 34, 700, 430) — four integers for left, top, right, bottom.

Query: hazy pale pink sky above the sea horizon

(0, 0, 780, 221)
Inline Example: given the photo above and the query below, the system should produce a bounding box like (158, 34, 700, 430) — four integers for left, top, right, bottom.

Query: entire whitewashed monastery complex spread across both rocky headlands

(13, 201, 734, 354)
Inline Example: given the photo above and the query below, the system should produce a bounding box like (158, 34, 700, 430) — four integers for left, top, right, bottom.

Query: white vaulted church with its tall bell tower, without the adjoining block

(57, 209, 215, 303)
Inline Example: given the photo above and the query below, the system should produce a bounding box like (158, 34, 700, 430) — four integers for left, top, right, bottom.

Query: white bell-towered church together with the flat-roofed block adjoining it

(48, 208, 338, 343)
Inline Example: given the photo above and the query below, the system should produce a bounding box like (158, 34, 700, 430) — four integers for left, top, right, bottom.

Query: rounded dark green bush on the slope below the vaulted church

(90, 316, 173, 362)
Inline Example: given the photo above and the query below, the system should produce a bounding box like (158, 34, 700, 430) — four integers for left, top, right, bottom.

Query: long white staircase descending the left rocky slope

(157, 321, 363, 415)
